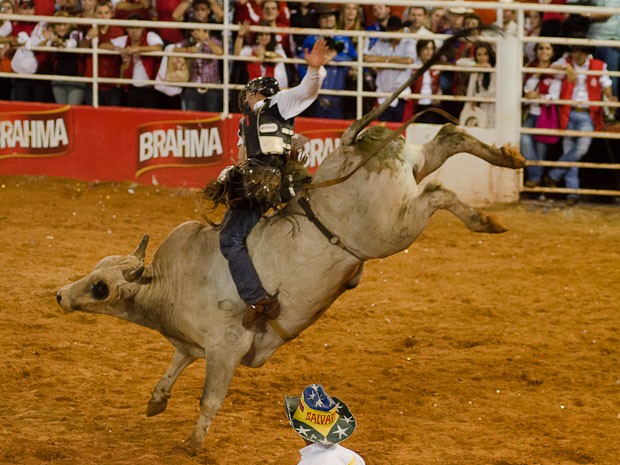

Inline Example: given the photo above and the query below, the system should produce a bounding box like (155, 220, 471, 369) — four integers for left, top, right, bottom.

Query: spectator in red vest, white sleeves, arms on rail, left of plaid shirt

(111, 14, 164, 108)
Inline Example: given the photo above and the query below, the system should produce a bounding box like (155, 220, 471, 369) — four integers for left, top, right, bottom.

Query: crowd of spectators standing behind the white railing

(0, 0, 620, 200)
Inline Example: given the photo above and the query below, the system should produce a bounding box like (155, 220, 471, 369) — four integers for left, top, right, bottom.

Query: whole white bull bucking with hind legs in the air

(57, 29, 525, 453)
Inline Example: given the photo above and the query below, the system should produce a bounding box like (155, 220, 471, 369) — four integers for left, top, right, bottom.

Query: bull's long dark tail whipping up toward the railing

(340, 26, 499, 145)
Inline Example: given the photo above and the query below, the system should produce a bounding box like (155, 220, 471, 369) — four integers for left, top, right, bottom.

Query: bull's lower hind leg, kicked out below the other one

(416, 181, 506, 234)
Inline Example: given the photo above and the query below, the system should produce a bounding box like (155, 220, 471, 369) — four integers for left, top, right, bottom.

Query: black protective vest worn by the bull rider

(240, 99, 295, 158)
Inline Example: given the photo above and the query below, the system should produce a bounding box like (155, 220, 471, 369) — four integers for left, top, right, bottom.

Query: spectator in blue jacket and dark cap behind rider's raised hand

(299, 3, 357, 119)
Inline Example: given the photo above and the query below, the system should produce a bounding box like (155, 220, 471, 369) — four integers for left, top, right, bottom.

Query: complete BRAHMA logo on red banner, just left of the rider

(136, 118, 224, 177)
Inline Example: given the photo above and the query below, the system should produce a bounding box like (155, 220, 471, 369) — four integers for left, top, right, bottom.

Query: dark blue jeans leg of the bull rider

(220, 208, 267, 304)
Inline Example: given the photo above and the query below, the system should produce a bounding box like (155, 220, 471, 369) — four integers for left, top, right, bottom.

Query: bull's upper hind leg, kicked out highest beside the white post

(415, 124, 525, 183)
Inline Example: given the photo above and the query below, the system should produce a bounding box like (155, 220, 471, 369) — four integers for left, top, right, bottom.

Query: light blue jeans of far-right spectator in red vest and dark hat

(549, 110, 594, 197)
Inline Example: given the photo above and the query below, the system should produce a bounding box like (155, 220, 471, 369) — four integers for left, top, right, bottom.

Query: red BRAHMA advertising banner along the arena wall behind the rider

(0, 102, 398, 187)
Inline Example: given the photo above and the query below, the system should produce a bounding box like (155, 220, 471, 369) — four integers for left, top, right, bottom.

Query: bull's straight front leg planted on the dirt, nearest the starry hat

(180, 328, 254, 455)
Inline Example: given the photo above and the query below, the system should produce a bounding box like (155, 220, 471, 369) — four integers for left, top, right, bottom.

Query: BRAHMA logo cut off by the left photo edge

(0, 106, 74, 158)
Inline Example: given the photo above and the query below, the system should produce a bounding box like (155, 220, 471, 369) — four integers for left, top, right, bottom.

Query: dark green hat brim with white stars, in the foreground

(284, 396, 357, 446)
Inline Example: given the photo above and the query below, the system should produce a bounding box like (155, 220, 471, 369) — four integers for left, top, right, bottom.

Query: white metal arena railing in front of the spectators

(0, 0, 620, 196)
